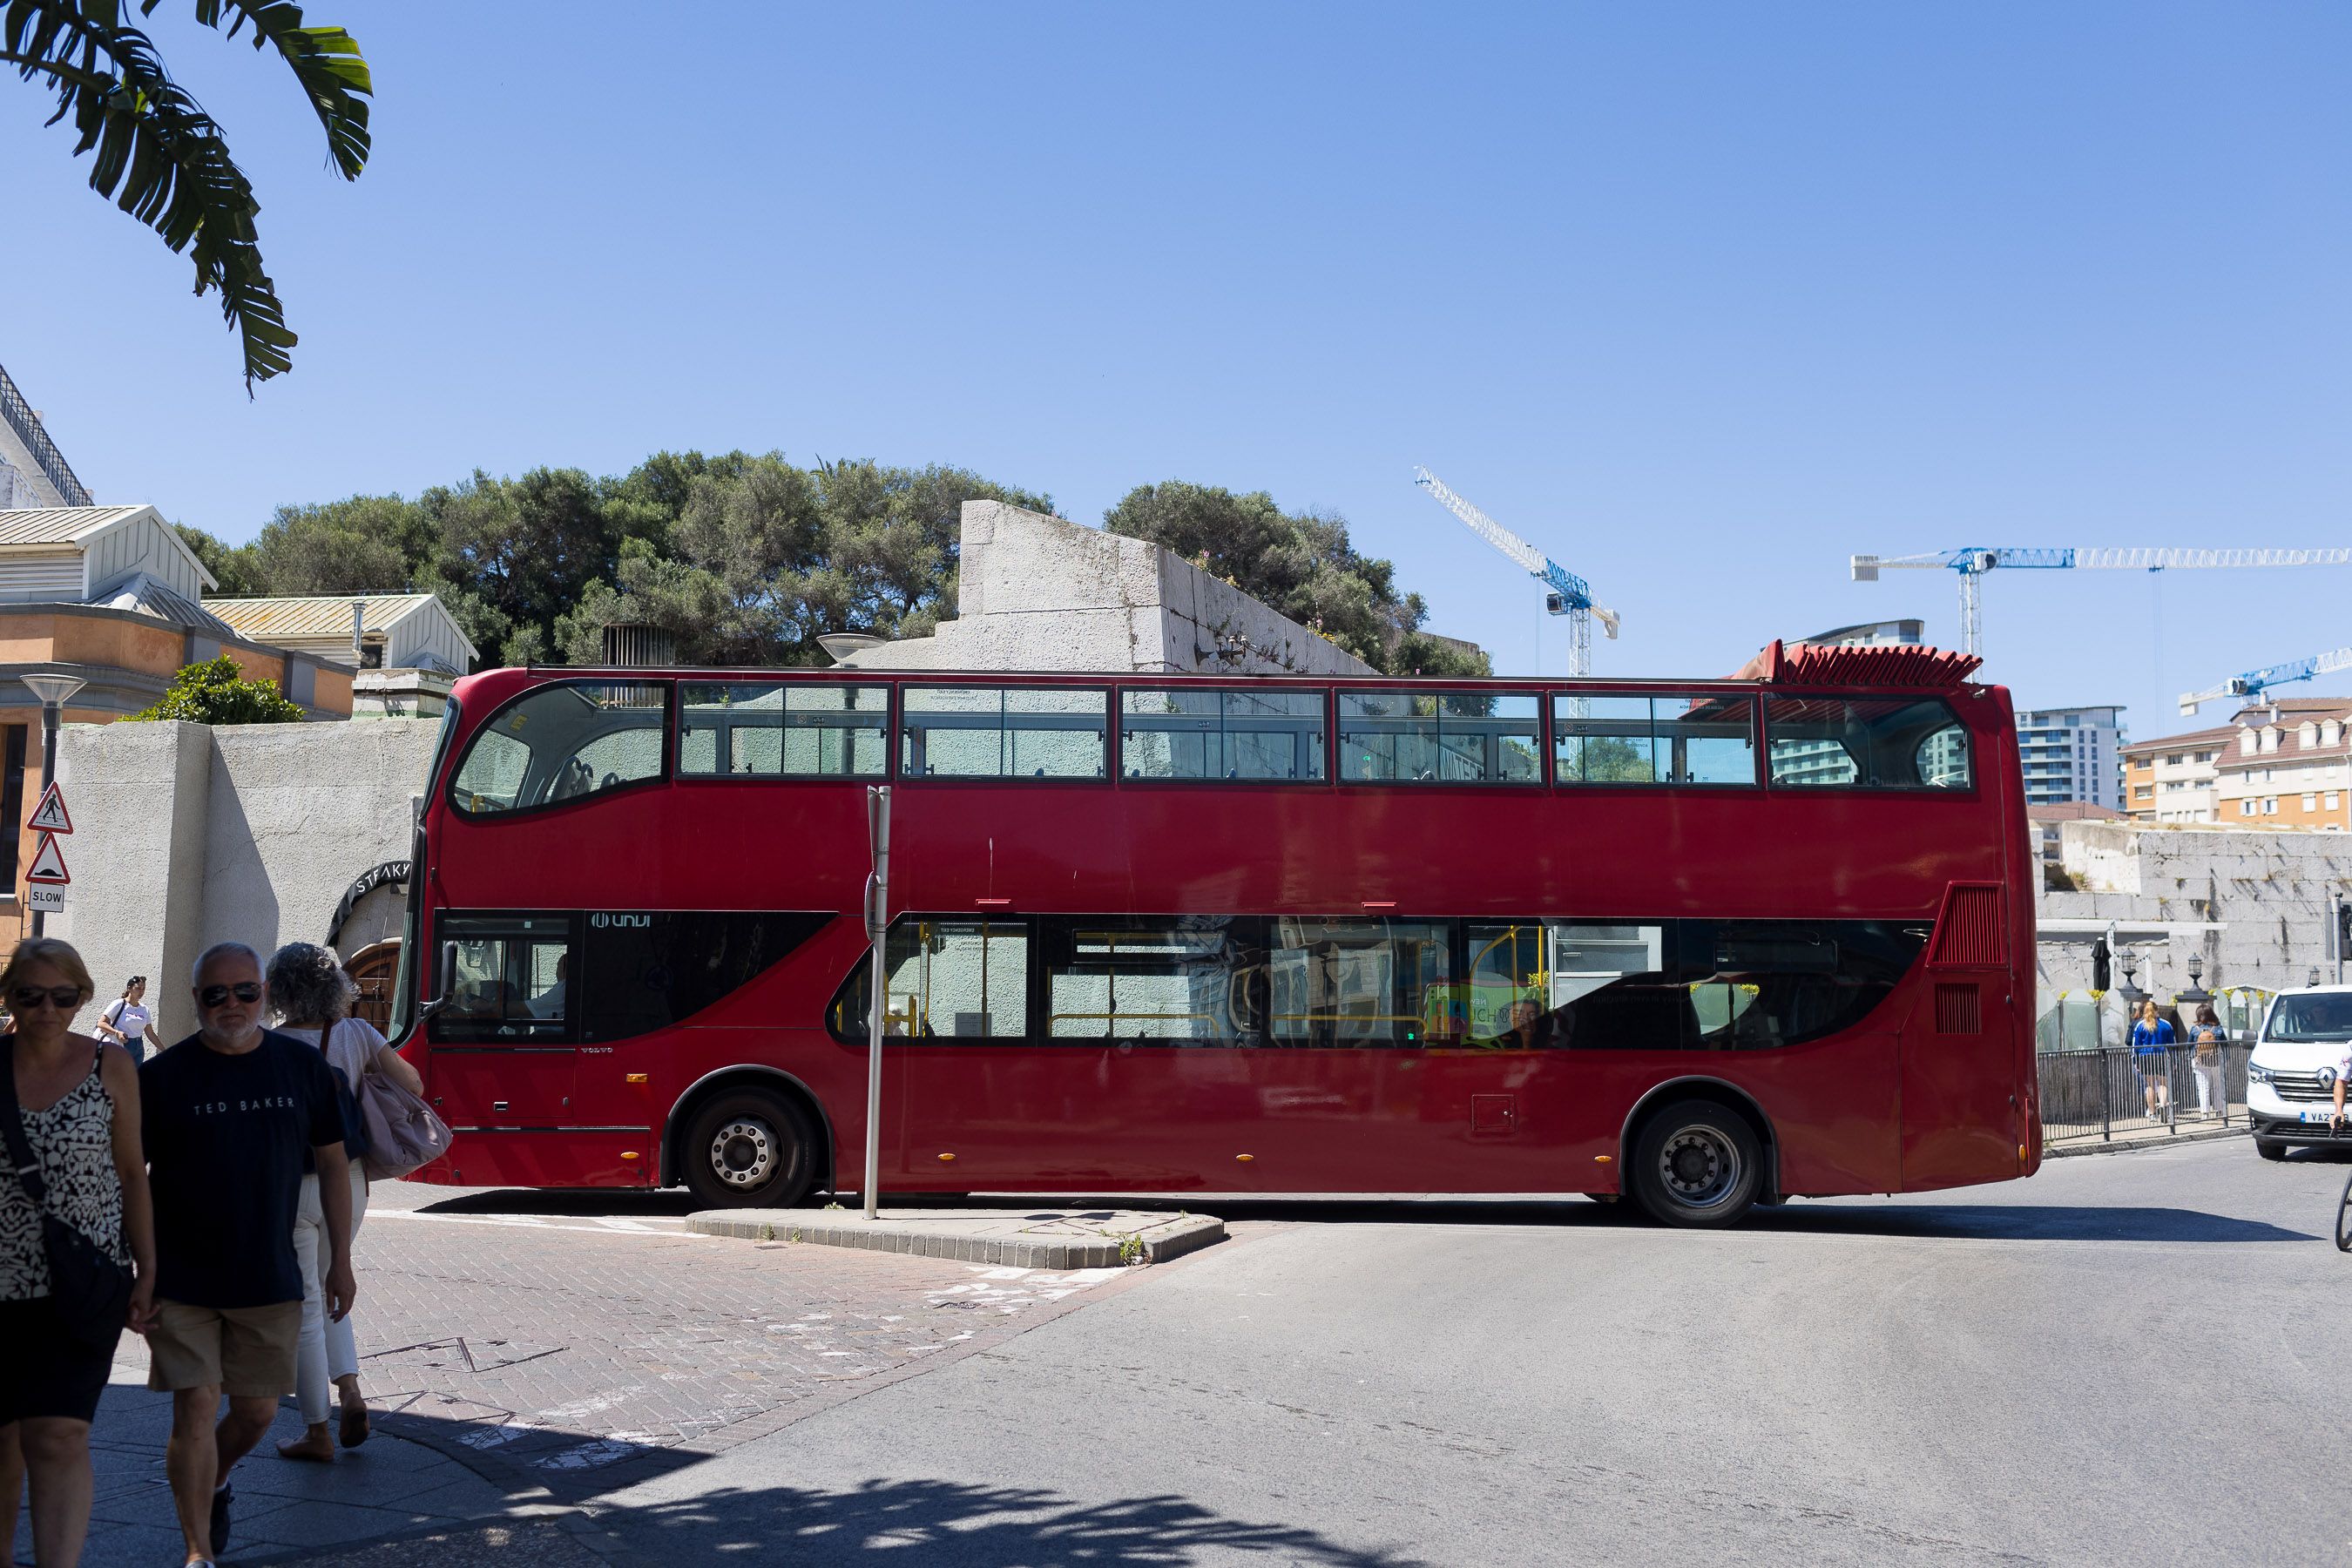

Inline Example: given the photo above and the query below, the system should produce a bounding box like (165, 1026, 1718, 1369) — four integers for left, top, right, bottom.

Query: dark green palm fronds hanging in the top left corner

(0, 0, 374, 393)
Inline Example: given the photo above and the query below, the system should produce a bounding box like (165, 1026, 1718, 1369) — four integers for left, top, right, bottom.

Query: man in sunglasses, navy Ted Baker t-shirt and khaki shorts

(139, 943, 355, 1564)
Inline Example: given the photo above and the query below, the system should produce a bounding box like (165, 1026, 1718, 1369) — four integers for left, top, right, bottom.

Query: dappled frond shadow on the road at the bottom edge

(598, 1481, 1421, 1568)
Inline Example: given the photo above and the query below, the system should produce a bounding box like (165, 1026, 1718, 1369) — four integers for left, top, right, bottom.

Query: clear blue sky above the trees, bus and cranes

(0, 0, 2352, 736)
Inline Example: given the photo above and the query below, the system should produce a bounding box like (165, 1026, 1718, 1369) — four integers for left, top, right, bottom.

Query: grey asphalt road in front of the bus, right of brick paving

(591, 1140, 2352, 1565)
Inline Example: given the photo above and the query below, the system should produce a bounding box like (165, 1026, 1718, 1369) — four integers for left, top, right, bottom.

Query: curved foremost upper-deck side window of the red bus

(449, 682, 668, 815)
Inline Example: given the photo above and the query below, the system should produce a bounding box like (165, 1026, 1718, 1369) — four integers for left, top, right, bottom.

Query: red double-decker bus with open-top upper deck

(395, 644, 2042, 1225)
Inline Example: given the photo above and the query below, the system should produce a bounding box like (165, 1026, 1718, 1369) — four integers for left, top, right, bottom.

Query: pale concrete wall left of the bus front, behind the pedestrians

(50, 720, 440, 1039)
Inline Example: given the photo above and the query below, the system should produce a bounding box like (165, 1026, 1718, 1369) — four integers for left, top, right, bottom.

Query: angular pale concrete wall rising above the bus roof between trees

(842, 501, 1371, 675)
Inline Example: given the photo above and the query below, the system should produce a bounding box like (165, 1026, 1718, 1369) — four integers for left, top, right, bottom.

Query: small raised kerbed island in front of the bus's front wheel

(686, 1208, 1226, 1269)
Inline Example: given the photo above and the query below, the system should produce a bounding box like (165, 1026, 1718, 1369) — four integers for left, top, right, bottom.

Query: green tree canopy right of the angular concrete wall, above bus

(1103, 480, 1489, 675)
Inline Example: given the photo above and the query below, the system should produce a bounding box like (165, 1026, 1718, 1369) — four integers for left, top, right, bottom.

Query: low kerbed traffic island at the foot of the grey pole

(686, 1208, 1226, 1269)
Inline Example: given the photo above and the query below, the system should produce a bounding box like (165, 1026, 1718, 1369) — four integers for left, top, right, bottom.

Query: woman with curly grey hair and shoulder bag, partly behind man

(268, 943, 426, 1463)
